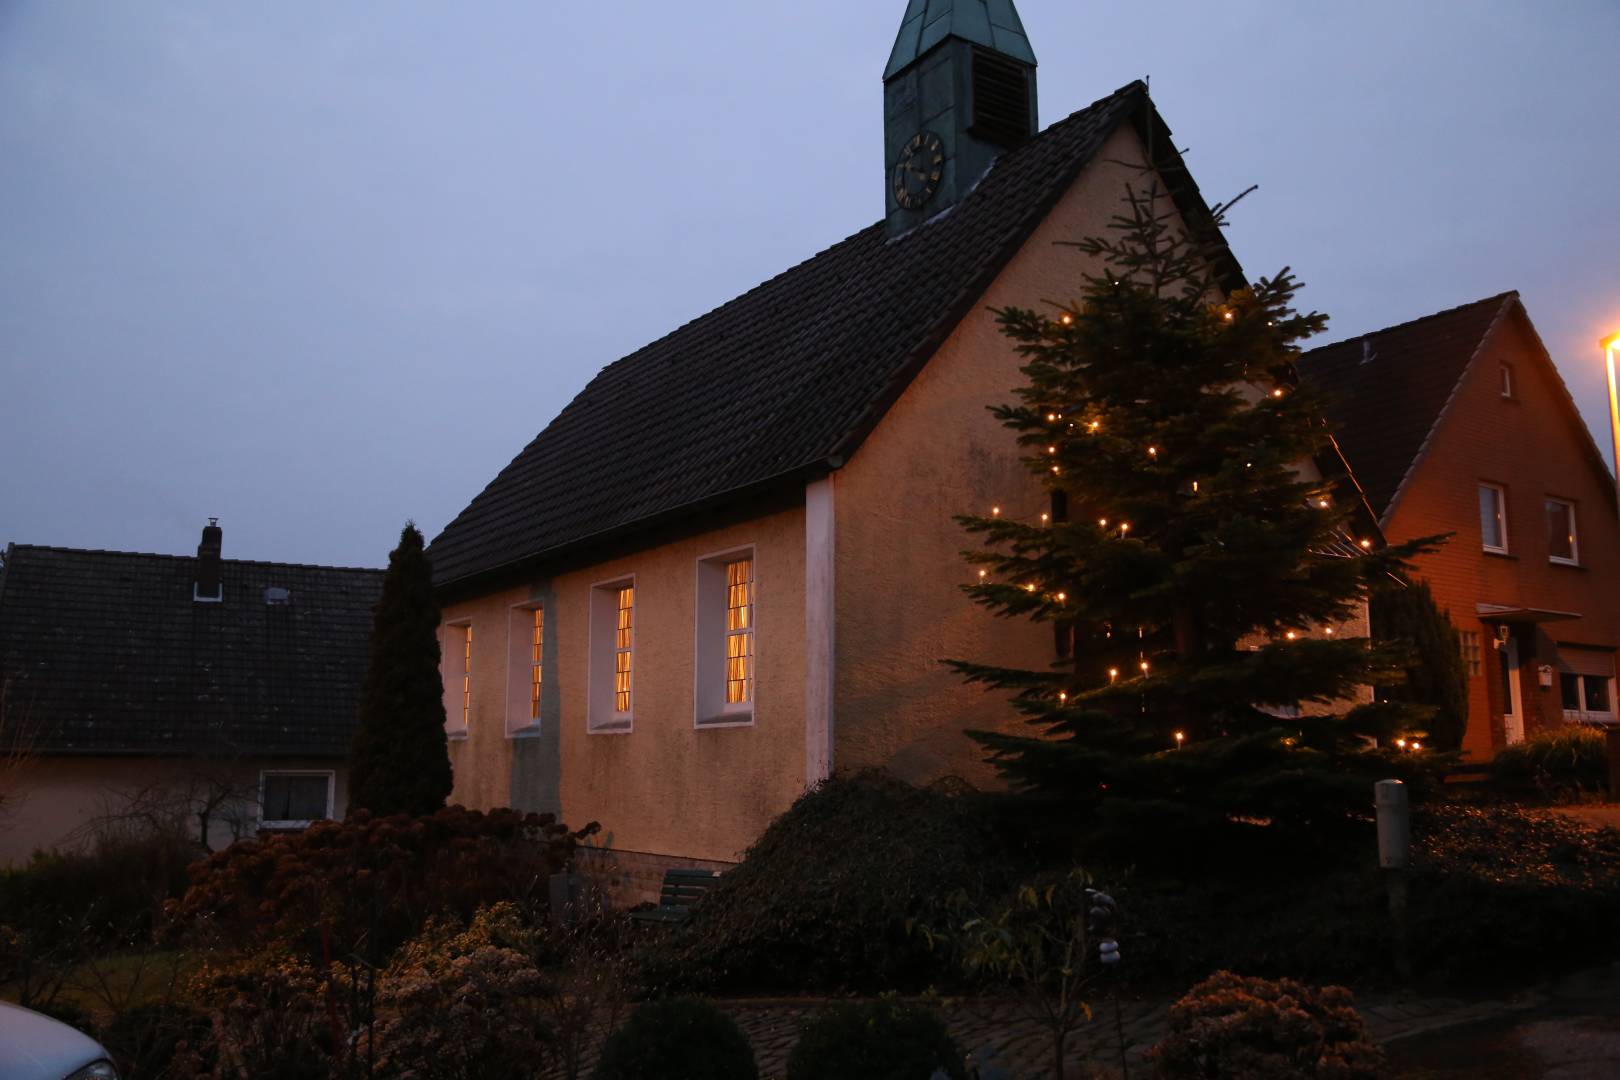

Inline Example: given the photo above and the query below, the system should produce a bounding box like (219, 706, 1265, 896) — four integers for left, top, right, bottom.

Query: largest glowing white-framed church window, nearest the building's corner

(693, 547, 758, 727)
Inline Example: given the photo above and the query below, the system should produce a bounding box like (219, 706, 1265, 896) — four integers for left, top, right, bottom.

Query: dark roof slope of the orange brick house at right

(1299, 293, 1518, 520)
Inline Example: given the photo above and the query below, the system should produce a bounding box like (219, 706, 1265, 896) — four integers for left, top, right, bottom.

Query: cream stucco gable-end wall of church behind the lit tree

(834, 126, 1257, 785)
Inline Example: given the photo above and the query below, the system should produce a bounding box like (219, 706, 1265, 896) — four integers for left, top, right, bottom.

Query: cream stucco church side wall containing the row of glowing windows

(444, 508, 805, 861)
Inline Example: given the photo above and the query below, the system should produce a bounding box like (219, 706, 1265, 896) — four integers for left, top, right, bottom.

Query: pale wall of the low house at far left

(0, 756, 348, 866)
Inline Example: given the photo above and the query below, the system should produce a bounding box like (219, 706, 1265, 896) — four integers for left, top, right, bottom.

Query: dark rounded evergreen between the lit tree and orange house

(1372, 581, 1468, 750)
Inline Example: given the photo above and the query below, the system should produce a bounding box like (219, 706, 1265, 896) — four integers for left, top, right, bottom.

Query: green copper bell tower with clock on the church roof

(883, 0, 1038, 236)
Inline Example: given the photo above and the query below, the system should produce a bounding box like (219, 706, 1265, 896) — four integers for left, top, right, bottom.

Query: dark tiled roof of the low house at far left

(0, 546, 382, 756)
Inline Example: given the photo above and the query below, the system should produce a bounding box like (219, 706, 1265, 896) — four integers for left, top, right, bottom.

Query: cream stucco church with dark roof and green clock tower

(429, 0, 1354, 887)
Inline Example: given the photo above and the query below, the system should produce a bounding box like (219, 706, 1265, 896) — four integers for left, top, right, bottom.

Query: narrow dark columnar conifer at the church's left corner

(348, 525, 452, 814)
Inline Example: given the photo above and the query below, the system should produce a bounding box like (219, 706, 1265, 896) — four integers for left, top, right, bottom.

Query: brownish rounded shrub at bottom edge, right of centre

(1150, 972, 1383, 1080)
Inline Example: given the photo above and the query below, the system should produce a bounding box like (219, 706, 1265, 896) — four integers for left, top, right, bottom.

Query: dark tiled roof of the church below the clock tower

(429, 83, 1243, 588)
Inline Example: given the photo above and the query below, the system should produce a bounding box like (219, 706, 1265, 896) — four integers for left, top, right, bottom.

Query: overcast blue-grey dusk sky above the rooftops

(0, 0, 1620, 565)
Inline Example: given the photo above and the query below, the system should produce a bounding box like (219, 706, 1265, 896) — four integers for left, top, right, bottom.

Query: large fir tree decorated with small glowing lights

(951, 180, 1429, 827)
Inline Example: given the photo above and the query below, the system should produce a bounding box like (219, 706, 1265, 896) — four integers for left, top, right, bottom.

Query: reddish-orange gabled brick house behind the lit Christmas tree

(1299, 293, 1620, 759)
